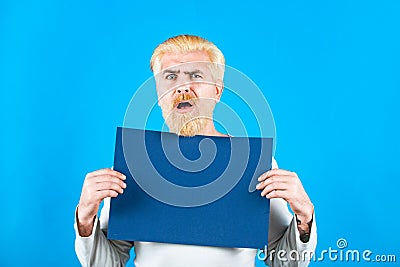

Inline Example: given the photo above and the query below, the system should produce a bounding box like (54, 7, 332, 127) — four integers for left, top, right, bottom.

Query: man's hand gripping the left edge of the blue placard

(77, 169, 126, 236)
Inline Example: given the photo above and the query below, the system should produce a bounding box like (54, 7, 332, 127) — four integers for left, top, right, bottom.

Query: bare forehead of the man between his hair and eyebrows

(161, 51, 211, 70)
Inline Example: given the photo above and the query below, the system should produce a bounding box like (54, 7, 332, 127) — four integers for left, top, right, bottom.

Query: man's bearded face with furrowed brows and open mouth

(155, 51, 222, 136)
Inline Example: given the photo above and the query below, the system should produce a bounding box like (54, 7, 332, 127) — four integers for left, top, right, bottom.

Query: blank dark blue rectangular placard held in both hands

(107, 128, 272, 248)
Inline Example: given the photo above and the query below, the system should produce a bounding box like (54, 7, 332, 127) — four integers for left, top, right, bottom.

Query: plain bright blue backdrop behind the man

(0, 0, 400, 266)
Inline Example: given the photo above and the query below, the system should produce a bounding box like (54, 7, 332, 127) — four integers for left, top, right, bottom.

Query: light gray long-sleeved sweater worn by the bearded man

(74, 161, 317, 267)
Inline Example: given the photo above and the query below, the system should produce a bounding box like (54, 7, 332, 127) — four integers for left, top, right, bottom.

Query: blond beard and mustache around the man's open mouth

(161, 94, 213, 136)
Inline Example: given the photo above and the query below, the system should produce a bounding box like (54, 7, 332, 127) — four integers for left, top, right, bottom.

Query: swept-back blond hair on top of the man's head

(150, 34, 225, 80)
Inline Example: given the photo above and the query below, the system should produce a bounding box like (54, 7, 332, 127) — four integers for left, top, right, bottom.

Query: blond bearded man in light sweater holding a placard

(75, 35, 317, 267)
